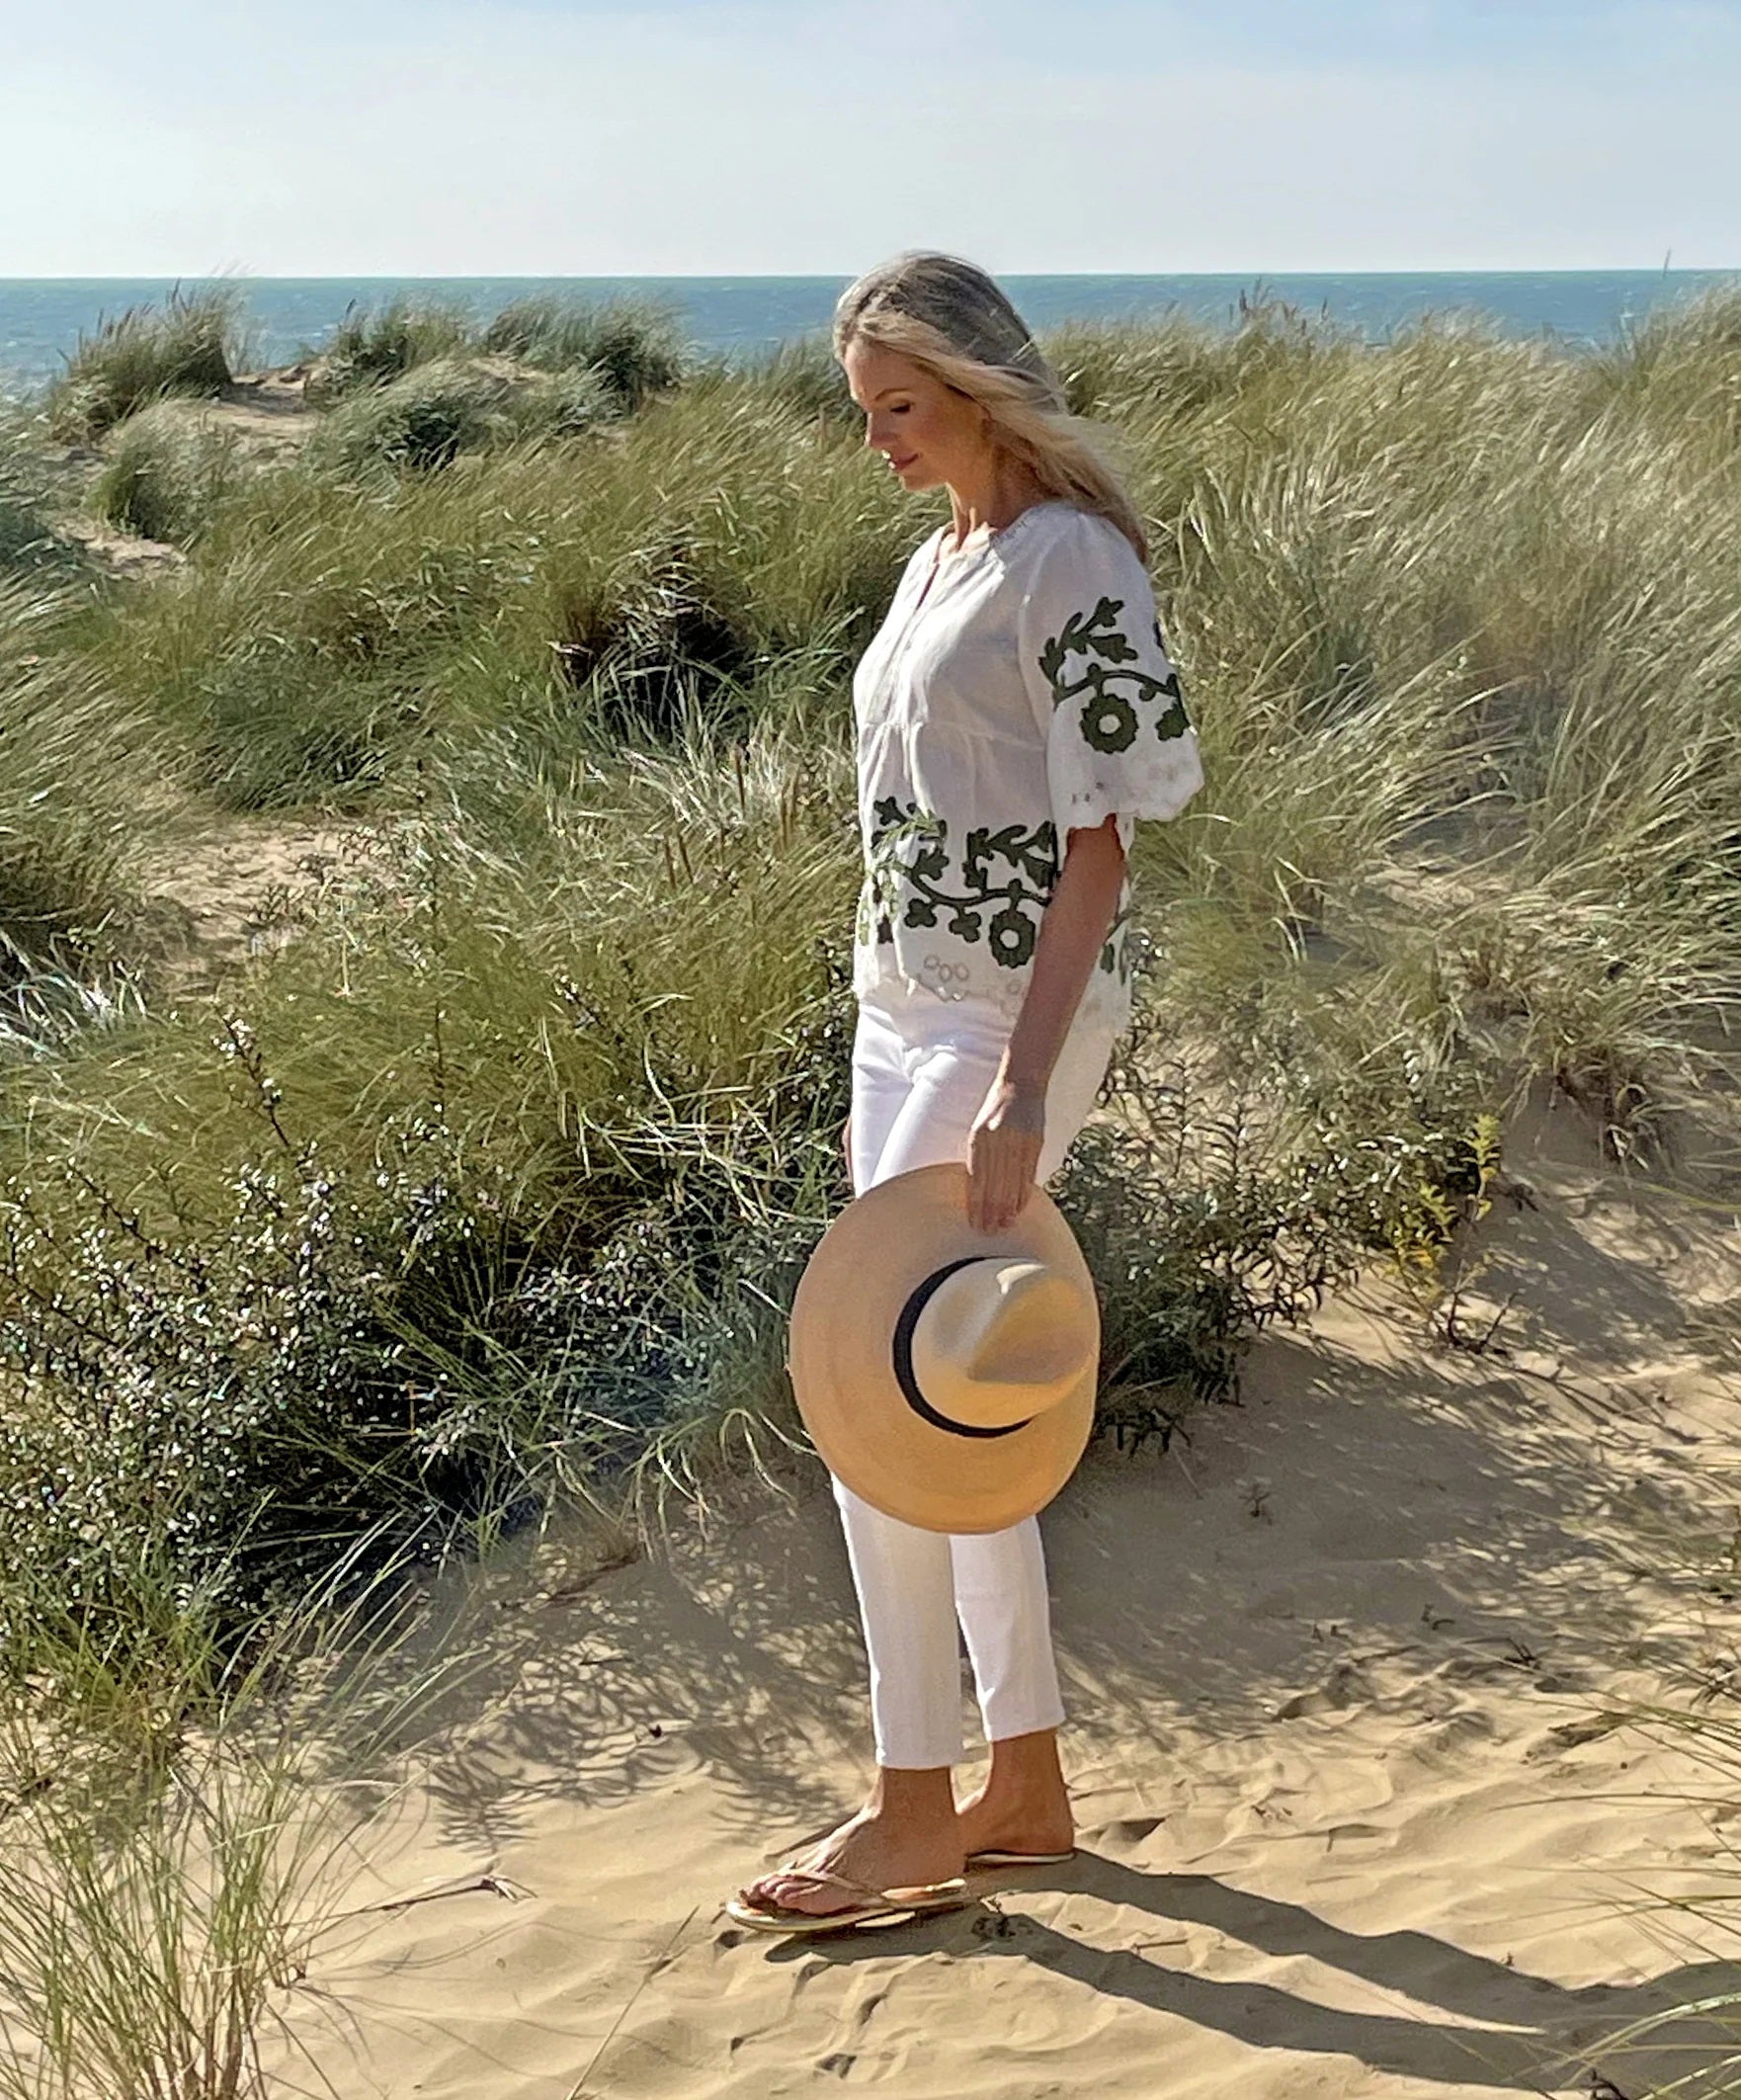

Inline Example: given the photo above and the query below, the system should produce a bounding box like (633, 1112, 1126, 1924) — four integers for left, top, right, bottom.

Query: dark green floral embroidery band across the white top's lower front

(857, 796, 1058, 970)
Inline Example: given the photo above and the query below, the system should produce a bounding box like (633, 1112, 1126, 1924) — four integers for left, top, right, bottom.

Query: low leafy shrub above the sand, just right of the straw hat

(1052, 993, 1485, 1449)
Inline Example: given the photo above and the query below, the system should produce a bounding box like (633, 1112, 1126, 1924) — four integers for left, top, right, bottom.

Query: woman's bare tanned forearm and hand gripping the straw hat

(968, 817, 1123, 1232)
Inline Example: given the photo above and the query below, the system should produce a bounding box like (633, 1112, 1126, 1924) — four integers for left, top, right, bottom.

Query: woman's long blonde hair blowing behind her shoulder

(834, 248, 1149, 567)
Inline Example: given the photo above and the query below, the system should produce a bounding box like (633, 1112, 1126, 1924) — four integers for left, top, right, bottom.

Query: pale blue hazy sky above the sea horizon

(0, 0, 1741, 278)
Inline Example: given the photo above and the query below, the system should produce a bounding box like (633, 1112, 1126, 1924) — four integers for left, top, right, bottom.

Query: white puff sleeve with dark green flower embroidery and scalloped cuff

(1017, 510, 1203, 866)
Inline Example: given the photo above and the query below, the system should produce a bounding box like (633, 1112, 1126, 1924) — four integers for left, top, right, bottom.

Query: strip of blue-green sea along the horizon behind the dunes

(0, 271, 1741, 392)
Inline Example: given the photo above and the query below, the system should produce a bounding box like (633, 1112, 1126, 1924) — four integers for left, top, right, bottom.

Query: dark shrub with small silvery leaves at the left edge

(0, 1100, 464, 1674)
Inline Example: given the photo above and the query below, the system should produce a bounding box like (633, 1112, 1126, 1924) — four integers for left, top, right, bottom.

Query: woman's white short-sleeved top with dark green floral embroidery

(853, 500, 1203, 1027)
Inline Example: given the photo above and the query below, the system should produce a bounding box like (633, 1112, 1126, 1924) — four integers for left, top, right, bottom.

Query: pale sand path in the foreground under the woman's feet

(264, 1100, 1741, 2100)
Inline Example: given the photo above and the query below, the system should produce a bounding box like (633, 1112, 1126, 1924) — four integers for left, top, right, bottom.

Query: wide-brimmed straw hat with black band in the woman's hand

(786, 1161, 1101, 1531)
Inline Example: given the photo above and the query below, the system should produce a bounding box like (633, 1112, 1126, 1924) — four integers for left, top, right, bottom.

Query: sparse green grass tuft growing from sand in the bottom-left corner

(0, 1556, 482, 2100)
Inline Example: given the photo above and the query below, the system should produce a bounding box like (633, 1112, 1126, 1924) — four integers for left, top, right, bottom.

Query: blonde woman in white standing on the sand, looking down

(739, 252, 1202, 1917)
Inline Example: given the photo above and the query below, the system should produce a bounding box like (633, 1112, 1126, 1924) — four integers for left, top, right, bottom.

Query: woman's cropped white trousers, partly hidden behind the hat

(834, 987, 1118, 1768)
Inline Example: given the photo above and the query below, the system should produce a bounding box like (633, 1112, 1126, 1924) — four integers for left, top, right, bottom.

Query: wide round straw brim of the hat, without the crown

(786, 1161, 1101, 1531)
